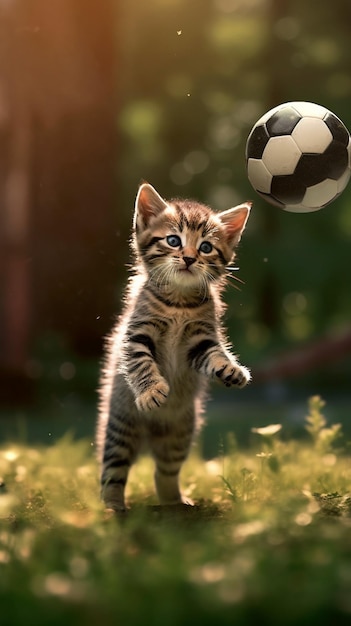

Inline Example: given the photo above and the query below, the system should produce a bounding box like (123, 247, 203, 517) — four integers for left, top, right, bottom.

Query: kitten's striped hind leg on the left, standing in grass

(101, 418, 140, 511)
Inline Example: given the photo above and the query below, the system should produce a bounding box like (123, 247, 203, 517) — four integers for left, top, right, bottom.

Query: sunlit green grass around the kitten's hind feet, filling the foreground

(0, 398, 351, 626)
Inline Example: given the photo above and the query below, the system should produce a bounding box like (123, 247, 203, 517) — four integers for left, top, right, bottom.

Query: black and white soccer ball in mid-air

(246, 102, 351, 213)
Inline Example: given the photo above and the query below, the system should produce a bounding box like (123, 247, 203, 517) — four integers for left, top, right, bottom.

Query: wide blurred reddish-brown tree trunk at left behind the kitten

(0, 0, 117, 400)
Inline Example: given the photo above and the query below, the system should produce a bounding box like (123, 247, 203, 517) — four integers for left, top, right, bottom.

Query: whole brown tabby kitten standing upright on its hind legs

(97, 184, 251, 511)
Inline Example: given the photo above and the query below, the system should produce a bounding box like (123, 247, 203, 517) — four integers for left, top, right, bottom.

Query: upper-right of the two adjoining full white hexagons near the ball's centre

(291, 117, 333, 154)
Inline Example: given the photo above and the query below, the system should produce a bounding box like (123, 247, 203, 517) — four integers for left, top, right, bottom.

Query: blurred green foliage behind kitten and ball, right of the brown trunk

(113, 0, 351, 386)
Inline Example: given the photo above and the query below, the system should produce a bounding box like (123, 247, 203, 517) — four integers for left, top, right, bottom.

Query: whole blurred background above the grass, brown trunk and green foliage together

(0, 0, 351, 426)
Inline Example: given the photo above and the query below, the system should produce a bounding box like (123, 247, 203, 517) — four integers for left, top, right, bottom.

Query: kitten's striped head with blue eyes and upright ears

(134, 183, 251, 291)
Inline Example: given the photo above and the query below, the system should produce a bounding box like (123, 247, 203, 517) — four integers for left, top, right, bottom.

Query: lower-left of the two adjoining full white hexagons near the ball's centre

(262, 135, 301, 176)
